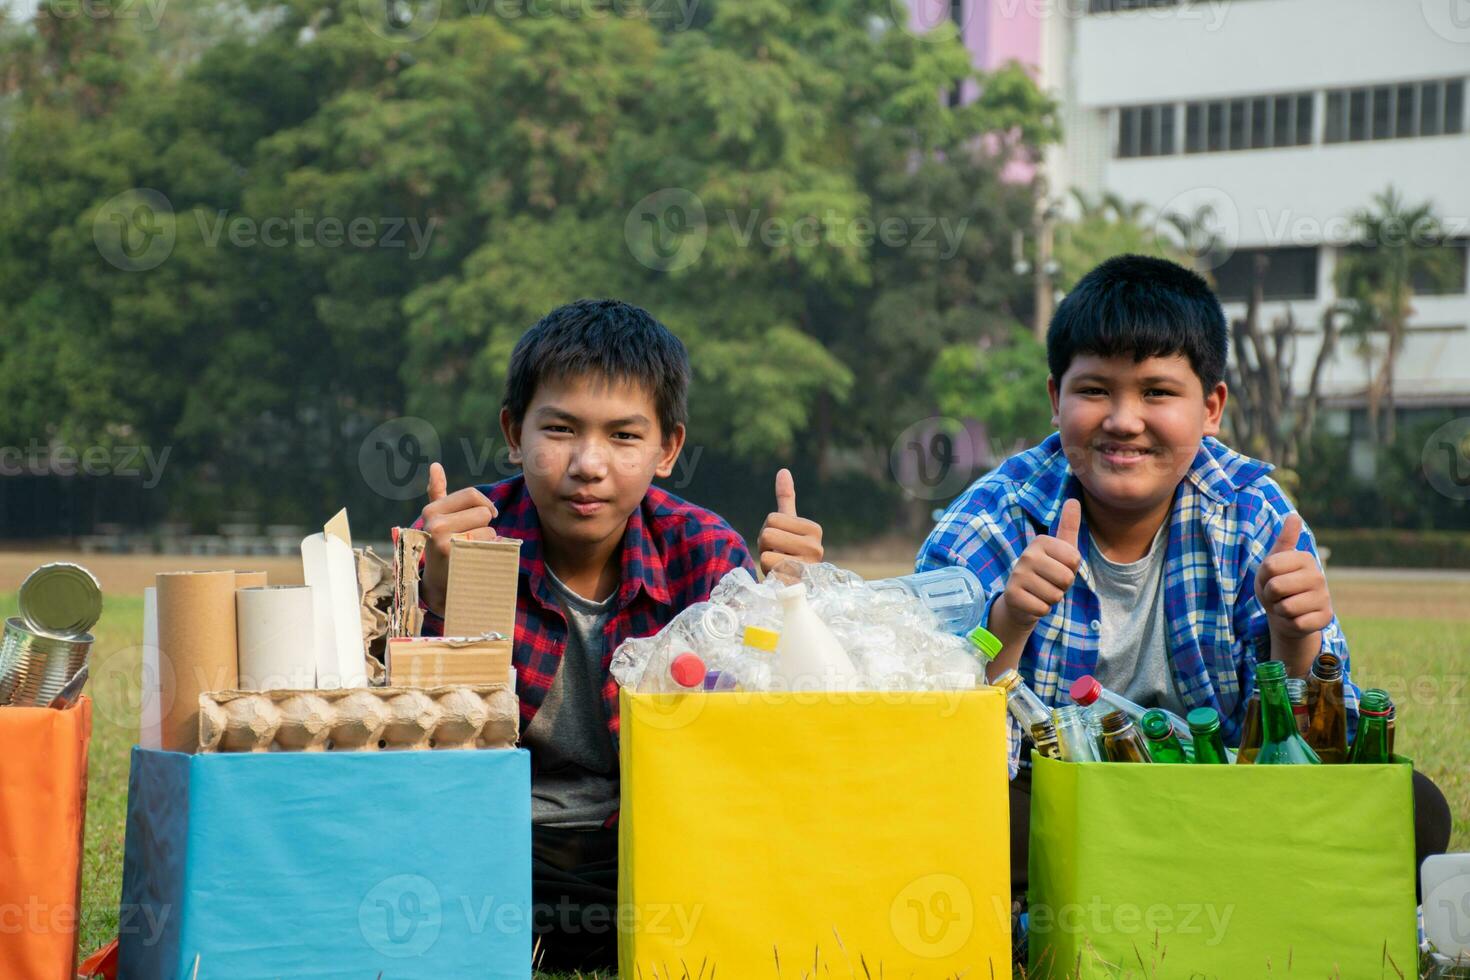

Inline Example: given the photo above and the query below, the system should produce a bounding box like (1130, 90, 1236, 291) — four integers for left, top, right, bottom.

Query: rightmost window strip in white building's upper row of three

(1326, 78, 1466, 143)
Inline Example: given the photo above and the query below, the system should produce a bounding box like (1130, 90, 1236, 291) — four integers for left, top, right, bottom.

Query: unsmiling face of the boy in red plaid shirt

(500, 375, 684, 551)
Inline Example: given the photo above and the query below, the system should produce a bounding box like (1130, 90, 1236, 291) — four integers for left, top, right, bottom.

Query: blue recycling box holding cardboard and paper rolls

(118, 748, 532, 980)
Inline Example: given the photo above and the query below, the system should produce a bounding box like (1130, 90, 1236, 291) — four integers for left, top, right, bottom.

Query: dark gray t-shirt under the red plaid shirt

(520, 569, 619, 830)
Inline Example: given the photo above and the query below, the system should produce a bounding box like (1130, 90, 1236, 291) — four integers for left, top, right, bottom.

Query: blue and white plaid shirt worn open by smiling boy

(916, 433, 1358, 774)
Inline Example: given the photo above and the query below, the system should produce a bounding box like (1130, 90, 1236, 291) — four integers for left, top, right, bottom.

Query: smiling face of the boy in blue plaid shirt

(1047, 354, 1226, 516)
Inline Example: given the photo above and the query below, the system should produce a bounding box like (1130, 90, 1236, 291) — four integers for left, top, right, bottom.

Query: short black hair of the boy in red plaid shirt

(501, 300, 689, 436)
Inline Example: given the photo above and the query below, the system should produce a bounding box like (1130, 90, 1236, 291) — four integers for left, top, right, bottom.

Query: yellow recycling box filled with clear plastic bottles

(619, 689, 1011, 980)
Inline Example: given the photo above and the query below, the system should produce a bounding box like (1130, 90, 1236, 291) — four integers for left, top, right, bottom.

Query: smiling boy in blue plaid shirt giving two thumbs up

(917, 256, 1449, 893)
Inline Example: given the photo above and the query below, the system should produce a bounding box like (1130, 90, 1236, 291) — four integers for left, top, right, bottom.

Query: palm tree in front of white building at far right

(1336, 187, 1463, 445)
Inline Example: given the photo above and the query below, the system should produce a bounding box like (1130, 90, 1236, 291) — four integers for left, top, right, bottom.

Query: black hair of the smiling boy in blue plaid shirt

(1047, 256, 1230, 394)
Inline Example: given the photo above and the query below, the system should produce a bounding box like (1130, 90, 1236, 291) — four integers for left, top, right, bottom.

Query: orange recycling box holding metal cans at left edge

(0, 698, 91, 980)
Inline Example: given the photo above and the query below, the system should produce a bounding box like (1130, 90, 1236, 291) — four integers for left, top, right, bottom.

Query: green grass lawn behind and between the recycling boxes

(0, 570, 1470, 976)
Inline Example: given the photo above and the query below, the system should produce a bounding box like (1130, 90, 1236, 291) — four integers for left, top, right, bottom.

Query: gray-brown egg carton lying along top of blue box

(198, 685, 520, 752)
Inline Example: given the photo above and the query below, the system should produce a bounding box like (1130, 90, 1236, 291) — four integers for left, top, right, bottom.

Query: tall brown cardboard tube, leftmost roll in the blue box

(157, 572, 240, 752)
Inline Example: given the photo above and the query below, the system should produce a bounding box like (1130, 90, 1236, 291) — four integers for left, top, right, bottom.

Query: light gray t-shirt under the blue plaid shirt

(1088, 520, 1186, 714)
